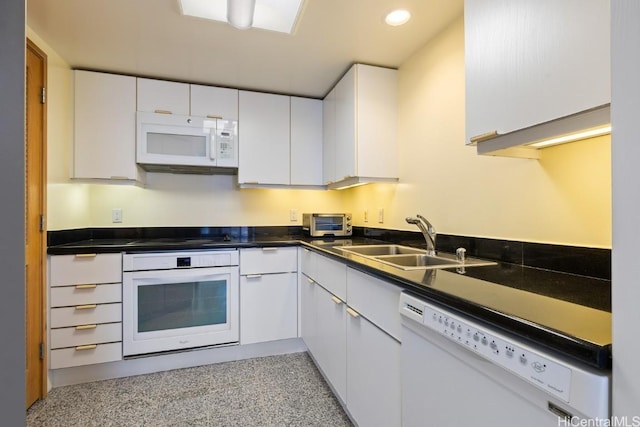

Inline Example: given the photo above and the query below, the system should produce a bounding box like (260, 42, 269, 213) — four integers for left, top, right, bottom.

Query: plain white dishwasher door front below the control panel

(401, 324, 569, 427)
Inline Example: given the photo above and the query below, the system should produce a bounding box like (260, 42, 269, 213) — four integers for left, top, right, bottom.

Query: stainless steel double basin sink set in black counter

(334, 245, 496, 270)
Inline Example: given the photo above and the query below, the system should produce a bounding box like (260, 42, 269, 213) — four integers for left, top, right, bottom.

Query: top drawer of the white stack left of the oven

(49, 253, 122, 286)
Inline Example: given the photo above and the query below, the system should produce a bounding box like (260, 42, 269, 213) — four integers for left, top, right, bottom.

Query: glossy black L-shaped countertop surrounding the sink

(48, 227, 611, 369)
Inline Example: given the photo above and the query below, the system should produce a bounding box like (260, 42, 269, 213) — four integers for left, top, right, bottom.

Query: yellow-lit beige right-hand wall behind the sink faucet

(346, 17, 611, 248)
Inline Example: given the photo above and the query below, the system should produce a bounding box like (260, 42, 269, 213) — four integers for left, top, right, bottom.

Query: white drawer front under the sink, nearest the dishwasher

(347, 268, 401, 340)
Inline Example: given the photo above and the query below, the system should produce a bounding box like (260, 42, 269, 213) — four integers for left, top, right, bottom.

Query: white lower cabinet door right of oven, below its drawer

(240, 273, 298, 344)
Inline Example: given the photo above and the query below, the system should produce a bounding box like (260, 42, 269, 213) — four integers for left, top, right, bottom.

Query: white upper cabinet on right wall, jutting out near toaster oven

(324, 64, 398, 187)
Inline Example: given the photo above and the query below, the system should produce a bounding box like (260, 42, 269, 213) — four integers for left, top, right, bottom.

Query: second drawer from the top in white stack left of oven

(50, 283, 122, 307)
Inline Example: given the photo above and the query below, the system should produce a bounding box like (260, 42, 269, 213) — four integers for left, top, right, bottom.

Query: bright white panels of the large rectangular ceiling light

(179, 0, 304, 34)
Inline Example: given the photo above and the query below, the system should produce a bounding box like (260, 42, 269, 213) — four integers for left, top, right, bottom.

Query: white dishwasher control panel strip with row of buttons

(400, 295, 571, 402)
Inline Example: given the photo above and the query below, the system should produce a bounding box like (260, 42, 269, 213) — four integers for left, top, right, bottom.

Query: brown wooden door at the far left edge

(25, 40, 47, 408)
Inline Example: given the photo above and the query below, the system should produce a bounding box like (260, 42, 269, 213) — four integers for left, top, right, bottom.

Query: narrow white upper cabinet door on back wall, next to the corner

(291, 96, 323, 185)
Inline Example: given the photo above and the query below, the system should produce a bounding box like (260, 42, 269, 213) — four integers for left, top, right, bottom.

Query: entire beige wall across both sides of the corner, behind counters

(28, 17, 611, 248)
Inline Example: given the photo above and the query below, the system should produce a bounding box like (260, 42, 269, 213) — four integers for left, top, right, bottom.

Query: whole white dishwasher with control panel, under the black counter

(400, 293, 610, 427)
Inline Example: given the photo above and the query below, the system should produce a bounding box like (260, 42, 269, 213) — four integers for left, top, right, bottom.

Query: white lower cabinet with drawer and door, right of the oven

(240, 247, 298, 344)
